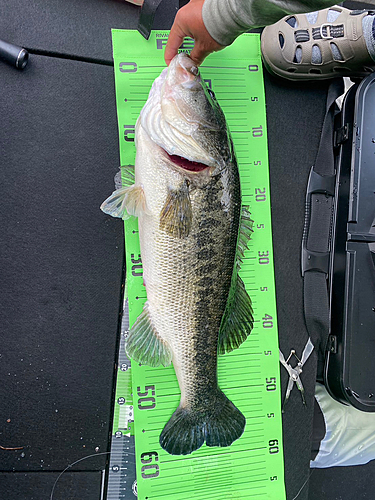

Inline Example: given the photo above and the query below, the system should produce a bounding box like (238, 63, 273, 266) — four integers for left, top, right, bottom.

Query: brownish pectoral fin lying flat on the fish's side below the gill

(159, 183, 193, 238)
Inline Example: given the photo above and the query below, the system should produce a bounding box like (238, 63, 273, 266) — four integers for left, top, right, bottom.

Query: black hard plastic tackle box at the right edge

(324, 74, 375, 412)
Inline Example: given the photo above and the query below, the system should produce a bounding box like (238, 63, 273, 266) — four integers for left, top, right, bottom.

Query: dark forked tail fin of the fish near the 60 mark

(159, 389, 246, 455)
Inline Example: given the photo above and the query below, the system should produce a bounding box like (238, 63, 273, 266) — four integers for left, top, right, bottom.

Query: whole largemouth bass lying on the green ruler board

(101, 54, 253, 455)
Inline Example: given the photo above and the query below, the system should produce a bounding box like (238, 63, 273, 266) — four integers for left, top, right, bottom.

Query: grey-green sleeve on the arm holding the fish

(202, 0, 352, 45)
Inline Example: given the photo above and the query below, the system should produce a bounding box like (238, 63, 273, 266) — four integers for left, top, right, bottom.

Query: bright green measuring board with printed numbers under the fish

(107, 30, 285, 500)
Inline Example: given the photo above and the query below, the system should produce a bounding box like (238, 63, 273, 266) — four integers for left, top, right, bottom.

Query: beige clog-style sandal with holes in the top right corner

(261, 5, 375, 80)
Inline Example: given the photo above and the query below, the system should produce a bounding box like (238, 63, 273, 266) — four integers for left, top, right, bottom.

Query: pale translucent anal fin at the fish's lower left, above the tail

(125, 302, 172, 366)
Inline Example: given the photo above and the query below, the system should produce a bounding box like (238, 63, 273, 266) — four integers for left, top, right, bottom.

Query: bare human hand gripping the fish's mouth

(164, 0, 224, 66)
